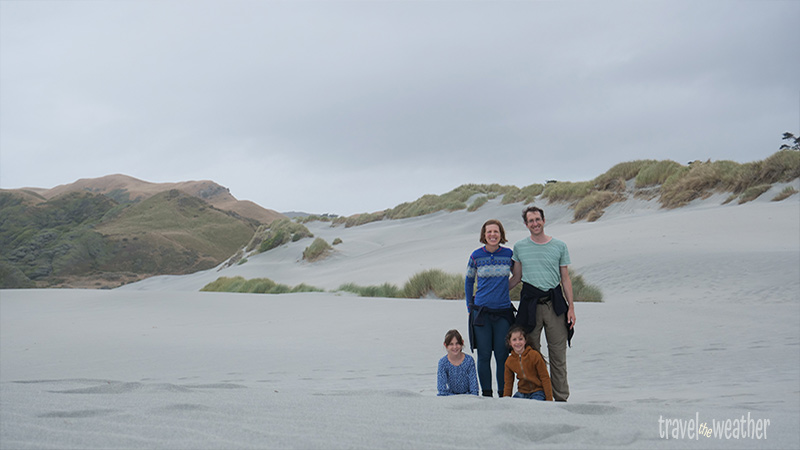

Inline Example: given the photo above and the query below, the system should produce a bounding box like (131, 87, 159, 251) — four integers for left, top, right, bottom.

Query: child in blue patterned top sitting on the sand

(436, 330, 478, 395)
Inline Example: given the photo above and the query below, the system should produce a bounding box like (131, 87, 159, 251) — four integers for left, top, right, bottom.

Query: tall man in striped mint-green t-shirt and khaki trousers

(512, 206, 575, 402)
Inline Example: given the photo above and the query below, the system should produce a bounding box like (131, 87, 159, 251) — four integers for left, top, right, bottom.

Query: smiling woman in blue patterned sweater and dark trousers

(464, 219, 520, 397)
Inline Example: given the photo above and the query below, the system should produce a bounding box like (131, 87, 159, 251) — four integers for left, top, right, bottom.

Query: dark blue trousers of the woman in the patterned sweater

(472, 311, 511, 396)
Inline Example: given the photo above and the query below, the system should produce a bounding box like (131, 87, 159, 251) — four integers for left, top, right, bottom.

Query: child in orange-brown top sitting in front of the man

(503, 326, 553, 401)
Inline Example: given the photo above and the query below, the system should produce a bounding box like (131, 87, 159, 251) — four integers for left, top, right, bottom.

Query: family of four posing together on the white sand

(438, 206, 575, 401)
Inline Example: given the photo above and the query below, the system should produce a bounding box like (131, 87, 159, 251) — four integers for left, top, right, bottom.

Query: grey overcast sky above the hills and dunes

(0, 0, 800, 215)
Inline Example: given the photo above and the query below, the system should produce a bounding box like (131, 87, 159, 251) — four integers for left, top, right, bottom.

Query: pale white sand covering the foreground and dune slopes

(0, 188, 800, 450)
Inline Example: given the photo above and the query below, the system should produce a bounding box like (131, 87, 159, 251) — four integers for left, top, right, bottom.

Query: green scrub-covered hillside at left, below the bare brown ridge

(0, 190, 258, 288)
